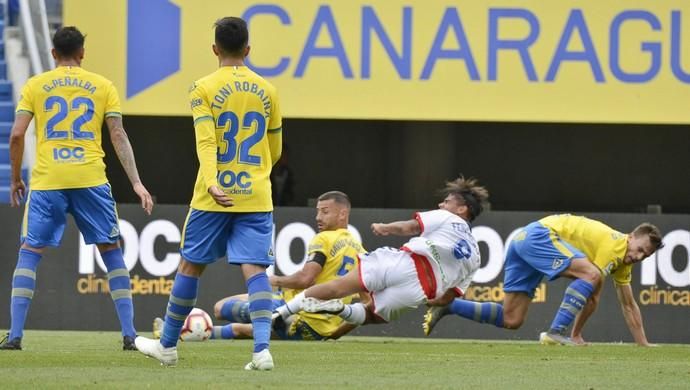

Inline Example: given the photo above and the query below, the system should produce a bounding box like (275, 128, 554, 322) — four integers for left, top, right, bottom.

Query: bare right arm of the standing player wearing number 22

(105, 116, 153, 215)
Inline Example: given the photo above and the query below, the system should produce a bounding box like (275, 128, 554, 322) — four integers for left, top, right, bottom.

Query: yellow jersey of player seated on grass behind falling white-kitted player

(283, 229, 365, 337)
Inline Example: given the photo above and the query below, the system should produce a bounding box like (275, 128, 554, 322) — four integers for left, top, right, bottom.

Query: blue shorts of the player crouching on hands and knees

(503, 222, 586, 297)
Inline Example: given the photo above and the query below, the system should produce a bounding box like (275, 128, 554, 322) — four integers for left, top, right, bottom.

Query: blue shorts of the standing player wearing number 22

(21, 183, 120, 248)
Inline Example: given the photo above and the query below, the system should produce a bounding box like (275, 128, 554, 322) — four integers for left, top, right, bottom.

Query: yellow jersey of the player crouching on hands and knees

(539, 214, 632, 285)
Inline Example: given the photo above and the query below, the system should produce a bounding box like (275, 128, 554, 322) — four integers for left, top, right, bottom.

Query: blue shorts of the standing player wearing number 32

(180, 209, 274, 267)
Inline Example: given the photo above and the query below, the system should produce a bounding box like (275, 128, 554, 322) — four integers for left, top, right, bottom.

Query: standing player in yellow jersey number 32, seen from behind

(135, 17, 282, 370)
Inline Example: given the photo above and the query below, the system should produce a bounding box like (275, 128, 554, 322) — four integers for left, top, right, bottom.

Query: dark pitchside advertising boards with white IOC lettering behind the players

(0, 204, 690, 343)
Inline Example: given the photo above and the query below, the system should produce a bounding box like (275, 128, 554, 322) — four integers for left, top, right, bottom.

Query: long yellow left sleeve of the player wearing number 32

(189, 83, 218, 189)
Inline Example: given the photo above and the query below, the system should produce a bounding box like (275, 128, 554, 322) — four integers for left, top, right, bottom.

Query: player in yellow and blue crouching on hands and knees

(424, 214, 663, 346)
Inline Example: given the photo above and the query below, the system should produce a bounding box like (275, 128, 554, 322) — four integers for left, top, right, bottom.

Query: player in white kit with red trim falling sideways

(277, 177, 488, 325)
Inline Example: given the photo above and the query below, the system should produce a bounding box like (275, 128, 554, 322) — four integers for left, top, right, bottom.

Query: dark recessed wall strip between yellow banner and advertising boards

(103, 116, 690, 214)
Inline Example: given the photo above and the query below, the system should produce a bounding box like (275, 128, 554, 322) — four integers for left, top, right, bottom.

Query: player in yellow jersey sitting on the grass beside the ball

(204, 191, 364, 340)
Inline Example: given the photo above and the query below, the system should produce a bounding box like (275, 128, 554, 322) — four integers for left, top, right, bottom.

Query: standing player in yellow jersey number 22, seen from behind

(0, 27, 153, 350)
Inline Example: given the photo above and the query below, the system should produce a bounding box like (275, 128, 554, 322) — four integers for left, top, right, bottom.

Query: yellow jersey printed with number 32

(189, 66, 282, 212)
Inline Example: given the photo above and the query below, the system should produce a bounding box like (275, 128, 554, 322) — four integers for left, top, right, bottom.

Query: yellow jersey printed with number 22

(17, 66, 122, 190)
